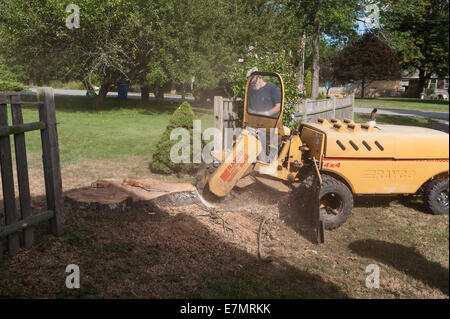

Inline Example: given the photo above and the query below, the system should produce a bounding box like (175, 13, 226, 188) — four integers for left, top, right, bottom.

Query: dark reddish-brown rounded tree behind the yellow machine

(332, 33, 401, 97)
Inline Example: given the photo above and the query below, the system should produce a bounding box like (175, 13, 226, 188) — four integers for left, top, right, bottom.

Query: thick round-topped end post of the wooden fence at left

(38, 87, 64, 236)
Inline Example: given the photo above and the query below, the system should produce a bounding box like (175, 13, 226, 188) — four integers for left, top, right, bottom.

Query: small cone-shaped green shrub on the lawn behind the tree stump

(150, 102, 195, 174)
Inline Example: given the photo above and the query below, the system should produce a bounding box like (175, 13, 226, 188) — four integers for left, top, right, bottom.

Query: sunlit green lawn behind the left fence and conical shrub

(15, 97, 214, 165)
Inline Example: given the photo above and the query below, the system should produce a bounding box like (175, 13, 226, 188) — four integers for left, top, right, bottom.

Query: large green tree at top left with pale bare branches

(0, 0, 136, 106)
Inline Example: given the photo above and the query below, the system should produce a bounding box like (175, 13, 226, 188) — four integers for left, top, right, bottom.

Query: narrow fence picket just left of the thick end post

(11, 96, 34, 248)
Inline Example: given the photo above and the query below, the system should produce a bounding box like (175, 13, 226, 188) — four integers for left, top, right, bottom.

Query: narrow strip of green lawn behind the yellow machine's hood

(355, 97, 449, 112)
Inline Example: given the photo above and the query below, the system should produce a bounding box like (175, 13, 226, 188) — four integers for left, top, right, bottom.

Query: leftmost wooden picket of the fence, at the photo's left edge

(0, 97, 20, 256)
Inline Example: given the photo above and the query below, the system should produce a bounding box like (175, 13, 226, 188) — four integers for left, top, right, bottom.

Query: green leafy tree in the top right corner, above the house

(381, 0, 449, 95)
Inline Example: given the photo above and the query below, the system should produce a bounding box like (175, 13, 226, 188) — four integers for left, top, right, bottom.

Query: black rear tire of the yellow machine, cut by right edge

(425, 178, 448, 215)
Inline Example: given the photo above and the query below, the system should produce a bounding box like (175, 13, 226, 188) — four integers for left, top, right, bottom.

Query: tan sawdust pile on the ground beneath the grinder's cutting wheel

(153, 185, 322, 261)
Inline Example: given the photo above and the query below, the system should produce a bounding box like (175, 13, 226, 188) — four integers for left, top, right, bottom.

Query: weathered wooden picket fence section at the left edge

(0, 88, 64, 259)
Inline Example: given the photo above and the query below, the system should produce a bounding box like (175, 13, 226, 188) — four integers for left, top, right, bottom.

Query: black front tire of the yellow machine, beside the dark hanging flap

(319, 175, 353, 230)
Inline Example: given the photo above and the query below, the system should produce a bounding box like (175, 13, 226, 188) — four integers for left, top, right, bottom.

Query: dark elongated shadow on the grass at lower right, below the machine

(349, 239, 449, 295)
